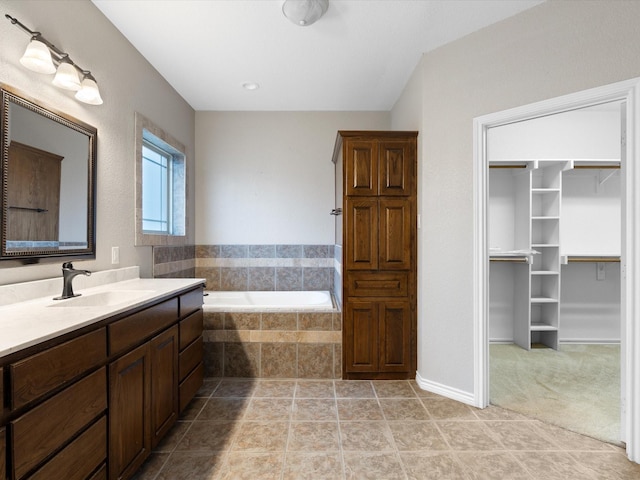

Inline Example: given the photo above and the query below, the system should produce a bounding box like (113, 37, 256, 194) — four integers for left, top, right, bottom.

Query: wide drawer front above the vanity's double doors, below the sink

(108, 298, 178, 355)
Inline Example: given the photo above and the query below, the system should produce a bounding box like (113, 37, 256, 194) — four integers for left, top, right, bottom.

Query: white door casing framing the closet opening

(473, 79, 640, 462)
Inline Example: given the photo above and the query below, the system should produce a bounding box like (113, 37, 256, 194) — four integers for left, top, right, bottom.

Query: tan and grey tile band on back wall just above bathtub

(195, 245, 335, 291)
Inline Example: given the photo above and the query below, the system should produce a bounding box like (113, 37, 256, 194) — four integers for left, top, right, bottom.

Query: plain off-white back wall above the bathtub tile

(196, 112, 389, 245)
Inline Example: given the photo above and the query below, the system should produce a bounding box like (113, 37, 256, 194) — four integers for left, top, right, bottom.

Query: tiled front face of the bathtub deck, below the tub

(203, 307, 342, 379)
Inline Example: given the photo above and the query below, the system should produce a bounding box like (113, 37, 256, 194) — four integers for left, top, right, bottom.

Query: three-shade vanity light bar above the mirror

(5, 14, 103, 105)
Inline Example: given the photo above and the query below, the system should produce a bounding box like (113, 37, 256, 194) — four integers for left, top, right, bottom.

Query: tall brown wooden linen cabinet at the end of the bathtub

(333, 131, 418, 379)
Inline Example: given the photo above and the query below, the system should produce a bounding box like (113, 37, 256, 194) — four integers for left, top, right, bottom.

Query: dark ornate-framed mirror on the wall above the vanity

(0, 85, 97, 264)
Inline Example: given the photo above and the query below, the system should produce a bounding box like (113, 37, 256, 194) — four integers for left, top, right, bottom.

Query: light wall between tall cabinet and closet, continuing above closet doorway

(392, 1, 640, 398)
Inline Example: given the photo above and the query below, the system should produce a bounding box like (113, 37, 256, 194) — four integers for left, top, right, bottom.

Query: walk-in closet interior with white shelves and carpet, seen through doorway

(487, 101, 624, 444)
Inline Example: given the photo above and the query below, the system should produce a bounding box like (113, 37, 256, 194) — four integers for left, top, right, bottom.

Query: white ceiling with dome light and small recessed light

(92, 0, 541, 111)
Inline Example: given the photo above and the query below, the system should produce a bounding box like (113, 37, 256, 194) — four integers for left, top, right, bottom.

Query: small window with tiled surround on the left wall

(136, 113, 186, 245)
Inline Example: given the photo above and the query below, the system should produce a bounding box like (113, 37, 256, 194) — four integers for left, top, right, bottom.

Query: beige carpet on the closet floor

(490, 344, 620, 444)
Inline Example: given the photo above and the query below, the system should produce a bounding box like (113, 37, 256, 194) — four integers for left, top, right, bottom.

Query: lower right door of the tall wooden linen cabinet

(380, 302, 411, 372)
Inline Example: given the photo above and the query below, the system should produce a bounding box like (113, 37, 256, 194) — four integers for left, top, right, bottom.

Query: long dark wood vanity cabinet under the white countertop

(0, 287, 202, 480)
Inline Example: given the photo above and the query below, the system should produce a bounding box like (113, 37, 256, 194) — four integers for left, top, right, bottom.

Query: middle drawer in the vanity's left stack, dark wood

(10, 367, 107, 479)
